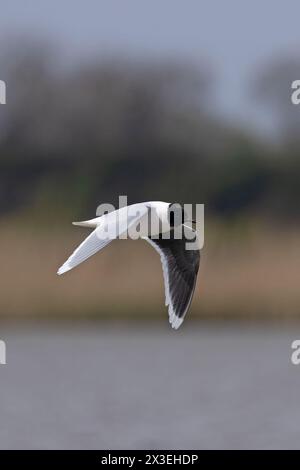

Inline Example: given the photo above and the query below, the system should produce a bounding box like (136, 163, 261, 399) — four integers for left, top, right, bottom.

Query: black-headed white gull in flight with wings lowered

(57, 201, 200, 329)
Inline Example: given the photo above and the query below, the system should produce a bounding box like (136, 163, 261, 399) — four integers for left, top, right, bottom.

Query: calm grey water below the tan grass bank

(0, 323, 300, 449)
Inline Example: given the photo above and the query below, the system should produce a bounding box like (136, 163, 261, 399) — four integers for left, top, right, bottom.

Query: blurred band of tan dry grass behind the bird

(0, 221, 300, 318)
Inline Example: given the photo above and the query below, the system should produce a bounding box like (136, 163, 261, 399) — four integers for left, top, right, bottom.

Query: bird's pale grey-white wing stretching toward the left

(57, 204, 148, 275)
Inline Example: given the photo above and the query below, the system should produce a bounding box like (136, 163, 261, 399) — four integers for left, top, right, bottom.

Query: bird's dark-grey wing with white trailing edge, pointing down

(145, 228, 200, 329)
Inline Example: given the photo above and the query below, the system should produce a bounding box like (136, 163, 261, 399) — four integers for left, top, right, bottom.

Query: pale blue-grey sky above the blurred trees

(0, 0, 300, 134)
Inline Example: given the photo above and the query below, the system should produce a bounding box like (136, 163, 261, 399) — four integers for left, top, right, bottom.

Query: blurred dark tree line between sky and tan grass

(0, 42, 300, 219)
